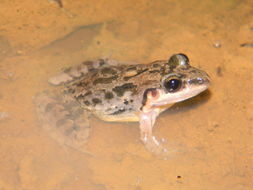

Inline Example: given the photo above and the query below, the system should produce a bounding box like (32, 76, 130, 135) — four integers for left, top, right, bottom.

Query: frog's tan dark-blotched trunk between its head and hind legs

(59, 60, 168, 121)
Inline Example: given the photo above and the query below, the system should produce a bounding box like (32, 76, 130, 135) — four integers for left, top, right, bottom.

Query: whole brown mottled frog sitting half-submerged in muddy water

(36, 53, 210, 154)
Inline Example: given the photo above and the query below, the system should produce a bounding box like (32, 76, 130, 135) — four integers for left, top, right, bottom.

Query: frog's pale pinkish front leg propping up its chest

(139, 90, 167, 154)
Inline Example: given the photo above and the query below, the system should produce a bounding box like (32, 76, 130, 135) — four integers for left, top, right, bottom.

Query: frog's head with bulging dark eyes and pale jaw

(149, 54, 210, 106)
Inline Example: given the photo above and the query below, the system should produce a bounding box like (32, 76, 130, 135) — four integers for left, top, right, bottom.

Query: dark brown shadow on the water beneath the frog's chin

(163, 90, 212, 115)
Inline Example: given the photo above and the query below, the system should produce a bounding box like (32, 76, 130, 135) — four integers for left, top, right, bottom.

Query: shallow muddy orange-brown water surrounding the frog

(0, 0, 253, 190)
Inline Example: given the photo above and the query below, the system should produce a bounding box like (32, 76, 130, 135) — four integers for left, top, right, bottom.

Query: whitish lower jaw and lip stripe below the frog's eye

(151, 85, 208, 106)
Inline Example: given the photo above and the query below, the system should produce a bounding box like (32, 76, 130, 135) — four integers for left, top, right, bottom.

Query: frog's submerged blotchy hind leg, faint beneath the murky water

(35, 93, 90, 150)
